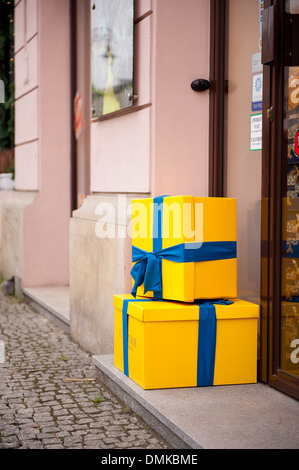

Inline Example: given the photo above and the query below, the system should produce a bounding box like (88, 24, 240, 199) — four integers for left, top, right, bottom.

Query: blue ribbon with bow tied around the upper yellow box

(131, 196, 237, 298)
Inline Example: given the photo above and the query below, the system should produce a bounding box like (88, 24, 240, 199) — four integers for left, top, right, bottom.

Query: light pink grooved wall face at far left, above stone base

(14, 0, 39, 191)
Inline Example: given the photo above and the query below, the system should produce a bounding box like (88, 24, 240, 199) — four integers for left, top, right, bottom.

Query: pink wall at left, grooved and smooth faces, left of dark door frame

(15, 0, 71, 287)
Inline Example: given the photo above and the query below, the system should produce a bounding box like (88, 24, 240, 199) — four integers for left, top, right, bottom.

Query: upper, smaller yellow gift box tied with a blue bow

(131, 196, 237, 302)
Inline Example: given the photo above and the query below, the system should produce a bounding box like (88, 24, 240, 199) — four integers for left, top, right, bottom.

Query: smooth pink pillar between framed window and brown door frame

(152, 0, 210, 196)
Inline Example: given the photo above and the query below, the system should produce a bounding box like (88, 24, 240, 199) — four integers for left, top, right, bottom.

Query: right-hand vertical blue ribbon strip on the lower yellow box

(196, 299, 233, 387)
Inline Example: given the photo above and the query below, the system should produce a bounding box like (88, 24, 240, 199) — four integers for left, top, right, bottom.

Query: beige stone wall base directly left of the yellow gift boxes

(70, 195, 138, 354)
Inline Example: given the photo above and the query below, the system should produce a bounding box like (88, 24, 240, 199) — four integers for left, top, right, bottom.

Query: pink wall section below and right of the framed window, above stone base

(91, 0, 210, 196)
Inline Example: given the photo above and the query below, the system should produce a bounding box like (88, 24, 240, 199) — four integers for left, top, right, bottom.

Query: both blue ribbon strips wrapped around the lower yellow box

(122, 299, 233, 387)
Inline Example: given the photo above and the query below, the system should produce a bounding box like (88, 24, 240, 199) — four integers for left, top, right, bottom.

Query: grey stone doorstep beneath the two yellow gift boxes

(93, 355, 299, 449)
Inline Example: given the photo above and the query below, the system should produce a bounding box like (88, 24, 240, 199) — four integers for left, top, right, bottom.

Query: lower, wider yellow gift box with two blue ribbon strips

(114, 295, 259, 389)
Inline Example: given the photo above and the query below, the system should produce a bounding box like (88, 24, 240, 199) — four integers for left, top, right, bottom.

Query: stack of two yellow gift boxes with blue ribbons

(114, 196, 259, 389)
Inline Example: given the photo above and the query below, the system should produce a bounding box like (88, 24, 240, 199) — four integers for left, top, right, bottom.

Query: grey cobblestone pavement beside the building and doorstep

(0, 292, 170, 449)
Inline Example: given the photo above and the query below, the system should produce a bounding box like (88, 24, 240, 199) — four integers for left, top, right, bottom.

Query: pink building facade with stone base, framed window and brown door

(1, 0, 299, 397)
